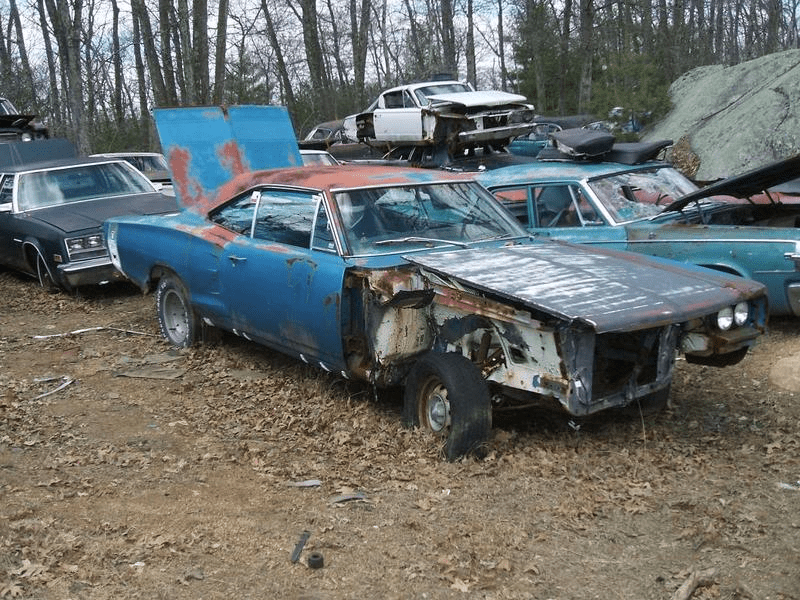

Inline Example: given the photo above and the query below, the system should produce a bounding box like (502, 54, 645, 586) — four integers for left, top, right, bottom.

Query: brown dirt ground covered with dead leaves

(0, 273, 800, 600)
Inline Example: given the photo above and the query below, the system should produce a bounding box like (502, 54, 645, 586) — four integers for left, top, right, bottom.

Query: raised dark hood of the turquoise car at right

(664, 154, 800, 212)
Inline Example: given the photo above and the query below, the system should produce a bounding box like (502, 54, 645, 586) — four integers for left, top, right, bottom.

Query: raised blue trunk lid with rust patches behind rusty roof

(153, 106, 303, 210)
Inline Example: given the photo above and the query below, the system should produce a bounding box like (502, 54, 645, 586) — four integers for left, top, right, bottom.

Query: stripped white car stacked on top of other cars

(343, 81, 535, 155)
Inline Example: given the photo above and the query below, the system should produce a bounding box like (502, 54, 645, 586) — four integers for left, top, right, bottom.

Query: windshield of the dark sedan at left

(17, 161, 154, 211)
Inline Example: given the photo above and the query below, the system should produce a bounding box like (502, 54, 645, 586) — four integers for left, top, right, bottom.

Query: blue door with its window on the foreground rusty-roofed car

(214, 188, 345, 370)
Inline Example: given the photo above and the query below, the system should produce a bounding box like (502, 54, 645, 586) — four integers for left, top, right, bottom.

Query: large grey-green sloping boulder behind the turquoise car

(644, 49, 800, 181)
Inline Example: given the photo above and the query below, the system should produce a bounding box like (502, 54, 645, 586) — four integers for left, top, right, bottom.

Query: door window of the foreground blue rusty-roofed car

(253, 190, 319, 248)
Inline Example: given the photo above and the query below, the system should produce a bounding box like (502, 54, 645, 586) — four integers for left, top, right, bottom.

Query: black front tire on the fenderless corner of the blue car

(403, 352, 492, 460)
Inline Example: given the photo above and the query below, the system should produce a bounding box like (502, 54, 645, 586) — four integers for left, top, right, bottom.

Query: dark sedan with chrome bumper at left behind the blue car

(0, 140, 177, 290)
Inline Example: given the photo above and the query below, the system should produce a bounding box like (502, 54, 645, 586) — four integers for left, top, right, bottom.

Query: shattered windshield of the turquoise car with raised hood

(589, 167, 697, 223)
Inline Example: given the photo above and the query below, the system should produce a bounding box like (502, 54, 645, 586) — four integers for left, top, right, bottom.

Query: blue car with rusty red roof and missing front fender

(105, 107, 767, 459)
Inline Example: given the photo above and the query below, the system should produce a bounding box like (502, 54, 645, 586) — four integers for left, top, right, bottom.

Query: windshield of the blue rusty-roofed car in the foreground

(334, 182, 527, 255)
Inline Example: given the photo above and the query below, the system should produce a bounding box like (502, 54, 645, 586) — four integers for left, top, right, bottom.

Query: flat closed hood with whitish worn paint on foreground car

(404, 242, 764, 333)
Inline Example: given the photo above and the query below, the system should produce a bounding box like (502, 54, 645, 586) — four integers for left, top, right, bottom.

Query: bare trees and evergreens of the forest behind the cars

(0, 0, 800, 154)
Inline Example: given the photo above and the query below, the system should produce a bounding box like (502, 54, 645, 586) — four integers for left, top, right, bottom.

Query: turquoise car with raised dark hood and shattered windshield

(476, 130, 800, 316)
